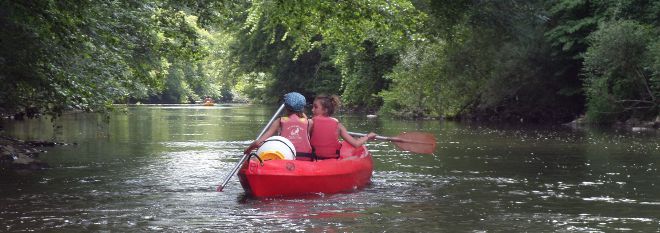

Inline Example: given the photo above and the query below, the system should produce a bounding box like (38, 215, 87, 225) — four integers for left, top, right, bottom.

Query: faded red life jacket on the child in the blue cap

(280, 114, 312, 155)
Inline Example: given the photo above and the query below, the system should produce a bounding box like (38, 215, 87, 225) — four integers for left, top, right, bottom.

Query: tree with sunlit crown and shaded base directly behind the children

(224, 0, 424, 105)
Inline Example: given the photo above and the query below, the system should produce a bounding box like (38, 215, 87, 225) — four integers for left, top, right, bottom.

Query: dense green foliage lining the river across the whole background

(0, 0, 660, 123)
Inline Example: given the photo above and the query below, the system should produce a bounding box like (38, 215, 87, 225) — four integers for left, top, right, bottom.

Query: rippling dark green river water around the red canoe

(0, 105, 660, 232)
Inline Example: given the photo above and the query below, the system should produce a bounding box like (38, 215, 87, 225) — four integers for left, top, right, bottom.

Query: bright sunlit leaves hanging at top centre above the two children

(244, 0, 424, 55)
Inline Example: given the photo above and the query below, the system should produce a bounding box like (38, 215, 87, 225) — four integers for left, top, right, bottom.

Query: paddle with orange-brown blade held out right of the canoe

(348, 132, 436, 154)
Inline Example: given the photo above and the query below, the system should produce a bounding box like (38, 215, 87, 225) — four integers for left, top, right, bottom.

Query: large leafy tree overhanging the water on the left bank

(0, 0, 202, 116)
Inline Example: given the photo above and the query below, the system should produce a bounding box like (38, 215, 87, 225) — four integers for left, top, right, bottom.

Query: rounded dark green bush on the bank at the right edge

(584, 20, 660, 123)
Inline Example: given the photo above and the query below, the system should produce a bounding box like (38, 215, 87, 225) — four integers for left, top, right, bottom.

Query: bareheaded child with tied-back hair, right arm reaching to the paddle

(310, 95, 376, 159)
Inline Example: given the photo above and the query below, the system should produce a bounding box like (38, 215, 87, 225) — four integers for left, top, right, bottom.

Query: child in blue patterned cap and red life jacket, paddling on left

(244, 92, 312, 160)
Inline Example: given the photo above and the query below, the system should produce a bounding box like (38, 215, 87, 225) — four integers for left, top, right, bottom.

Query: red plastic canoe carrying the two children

(238, 142, 373, 197)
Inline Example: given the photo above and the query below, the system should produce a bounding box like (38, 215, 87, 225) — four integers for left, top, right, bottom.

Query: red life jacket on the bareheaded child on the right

(311, 116, 341, 159)
